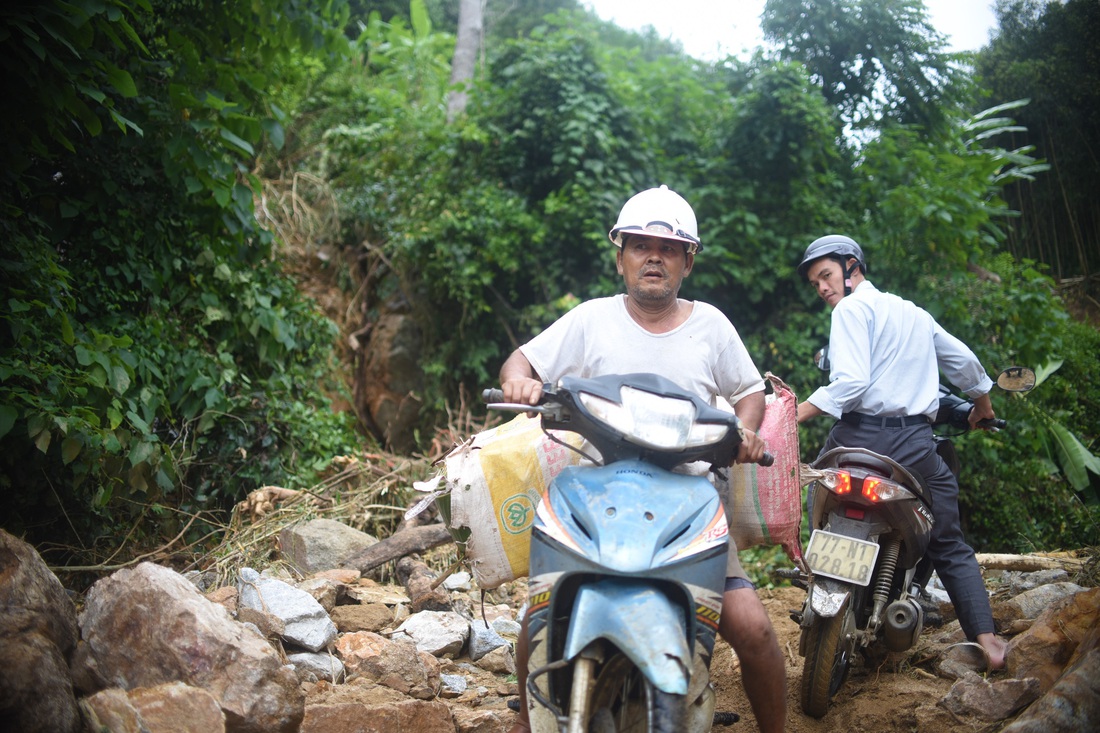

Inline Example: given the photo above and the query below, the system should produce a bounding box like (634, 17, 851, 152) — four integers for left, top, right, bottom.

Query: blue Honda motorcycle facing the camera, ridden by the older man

(484, 374, 771, 733)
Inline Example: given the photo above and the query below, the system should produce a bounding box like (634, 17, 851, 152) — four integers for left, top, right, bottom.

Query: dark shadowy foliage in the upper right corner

(975, 0, 1100, 280)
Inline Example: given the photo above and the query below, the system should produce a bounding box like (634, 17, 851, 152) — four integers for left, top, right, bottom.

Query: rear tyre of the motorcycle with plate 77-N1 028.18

(801, 603, 855, 718)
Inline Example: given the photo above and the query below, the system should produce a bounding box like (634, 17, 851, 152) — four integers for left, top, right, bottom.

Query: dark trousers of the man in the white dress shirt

(822, 422, 994, 641)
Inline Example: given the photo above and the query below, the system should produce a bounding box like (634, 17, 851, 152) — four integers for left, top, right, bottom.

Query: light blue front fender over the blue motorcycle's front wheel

(564, 579, 693, 694)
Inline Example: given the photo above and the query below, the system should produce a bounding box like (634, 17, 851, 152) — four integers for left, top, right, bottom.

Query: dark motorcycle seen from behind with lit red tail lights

(788, 352, 1035, 718)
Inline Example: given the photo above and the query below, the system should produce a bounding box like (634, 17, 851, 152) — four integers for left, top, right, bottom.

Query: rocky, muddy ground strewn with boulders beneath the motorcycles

(0, 512, 1100, 733)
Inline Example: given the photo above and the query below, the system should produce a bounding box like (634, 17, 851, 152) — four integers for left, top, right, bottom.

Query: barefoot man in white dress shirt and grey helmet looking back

(798, 234, 1005, 669)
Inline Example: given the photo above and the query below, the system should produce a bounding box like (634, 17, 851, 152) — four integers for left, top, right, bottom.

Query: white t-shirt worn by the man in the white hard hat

(520, 294, 763, 405)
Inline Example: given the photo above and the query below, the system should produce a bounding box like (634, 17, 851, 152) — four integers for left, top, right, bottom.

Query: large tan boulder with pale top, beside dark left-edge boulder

(74, 562, 305, 733)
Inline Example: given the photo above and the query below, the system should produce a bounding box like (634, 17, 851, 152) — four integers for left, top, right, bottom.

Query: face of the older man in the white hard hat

(616, 234, 695, 303)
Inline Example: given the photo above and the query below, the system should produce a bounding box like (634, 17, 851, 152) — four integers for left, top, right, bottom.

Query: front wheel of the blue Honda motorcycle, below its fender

(582, 653, 686, 733)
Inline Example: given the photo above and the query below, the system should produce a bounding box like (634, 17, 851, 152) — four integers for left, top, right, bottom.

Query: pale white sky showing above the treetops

(583, 0, 997, 61)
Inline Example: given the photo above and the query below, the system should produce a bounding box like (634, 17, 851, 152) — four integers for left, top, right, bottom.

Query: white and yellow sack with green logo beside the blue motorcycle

(444, 414, 582, 590)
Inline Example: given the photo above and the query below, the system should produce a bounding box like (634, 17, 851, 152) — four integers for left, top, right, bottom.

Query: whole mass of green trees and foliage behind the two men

(0, 0, 1100, 561)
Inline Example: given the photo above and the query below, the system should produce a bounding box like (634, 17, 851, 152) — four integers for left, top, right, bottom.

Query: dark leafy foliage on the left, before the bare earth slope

(0, 1, 353, 556)
